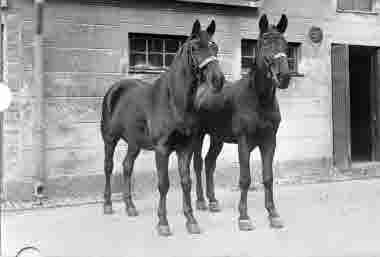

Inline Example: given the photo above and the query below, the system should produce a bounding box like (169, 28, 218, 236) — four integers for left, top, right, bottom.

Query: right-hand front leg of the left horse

(177, 143, 201, 234)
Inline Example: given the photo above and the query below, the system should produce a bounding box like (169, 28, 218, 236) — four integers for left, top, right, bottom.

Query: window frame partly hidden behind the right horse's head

(240, 38, 303, 77)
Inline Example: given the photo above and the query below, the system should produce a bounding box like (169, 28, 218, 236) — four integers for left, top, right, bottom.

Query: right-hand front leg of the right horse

(259, 136, 284, 228)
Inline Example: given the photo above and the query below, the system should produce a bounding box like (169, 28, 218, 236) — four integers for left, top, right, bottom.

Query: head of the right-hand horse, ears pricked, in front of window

(256, 14, 290, 89)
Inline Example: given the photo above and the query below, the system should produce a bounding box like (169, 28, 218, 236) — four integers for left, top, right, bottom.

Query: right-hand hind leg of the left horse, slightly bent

(123, 144, 140, 216)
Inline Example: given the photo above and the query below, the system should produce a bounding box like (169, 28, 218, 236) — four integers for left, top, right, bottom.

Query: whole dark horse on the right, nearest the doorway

(193, 14, 290, 230)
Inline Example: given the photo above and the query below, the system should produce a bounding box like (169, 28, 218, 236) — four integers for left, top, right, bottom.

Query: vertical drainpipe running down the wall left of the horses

(32, 0, 47, 203)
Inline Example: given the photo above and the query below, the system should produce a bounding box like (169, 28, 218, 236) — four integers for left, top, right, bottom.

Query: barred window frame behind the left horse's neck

(128, 33, 187, 73)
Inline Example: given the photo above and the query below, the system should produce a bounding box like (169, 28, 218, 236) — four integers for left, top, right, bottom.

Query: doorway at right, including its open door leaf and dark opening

(331, 44, 380, 169)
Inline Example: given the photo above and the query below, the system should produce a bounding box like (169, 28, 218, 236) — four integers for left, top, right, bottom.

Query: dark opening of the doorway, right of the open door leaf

(349, 46, 375, 161)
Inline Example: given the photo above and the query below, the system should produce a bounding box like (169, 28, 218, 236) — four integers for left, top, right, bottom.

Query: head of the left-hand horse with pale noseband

(188, 20, 225, 109)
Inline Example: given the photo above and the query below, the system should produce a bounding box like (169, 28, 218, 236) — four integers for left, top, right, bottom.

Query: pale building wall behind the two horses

(4, 0, 380, 198)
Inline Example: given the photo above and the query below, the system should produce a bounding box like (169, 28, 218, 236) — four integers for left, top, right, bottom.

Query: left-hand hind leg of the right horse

(193, 135, 207, 210)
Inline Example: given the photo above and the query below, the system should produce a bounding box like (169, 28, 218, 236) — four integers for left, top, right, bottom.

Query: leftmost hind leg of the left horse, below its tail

(103, 139, 117, 214)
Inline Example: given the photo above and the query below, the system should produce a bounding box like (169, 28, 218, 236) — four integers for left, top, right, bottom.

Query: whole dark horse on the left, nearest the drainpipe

(101, 20, 224, 236)
